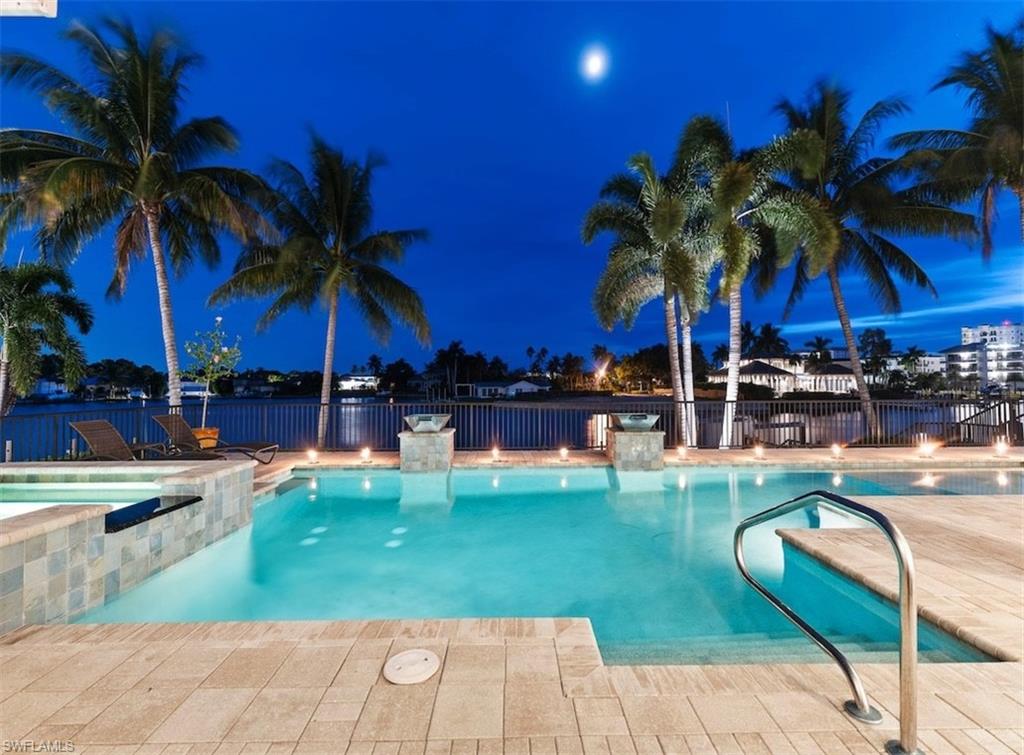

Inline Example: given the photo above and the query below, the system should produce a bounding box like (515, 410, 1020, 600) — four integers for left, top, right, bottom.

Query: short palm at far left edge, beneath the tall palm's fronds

(0, 262, 92, 417)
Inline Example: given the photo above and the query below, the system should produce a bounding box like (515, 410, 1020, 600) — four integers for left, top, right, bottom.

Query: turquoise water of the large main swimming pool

(74, 468, 1022, 663)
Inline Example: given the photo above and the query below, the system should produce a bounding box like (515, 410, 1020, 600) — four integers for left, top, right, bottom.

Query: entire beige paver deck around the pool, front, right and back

(0, 449, 1024, 755)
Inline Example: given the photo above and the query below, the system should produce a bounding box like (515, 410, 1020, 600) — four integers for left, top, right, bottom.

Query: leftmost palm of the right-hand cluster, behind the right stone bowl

(582, 154, 701, 445)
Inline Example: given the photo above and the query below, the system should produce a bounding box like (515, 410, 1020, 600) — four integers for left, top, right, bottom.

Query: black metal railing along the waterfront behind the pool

(0, 399, 1024, 461)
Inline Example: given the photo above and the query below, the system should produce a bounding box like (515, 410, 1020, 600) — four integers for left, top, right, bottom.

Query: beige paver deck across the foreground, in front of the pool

(0, 619, 1024, 755)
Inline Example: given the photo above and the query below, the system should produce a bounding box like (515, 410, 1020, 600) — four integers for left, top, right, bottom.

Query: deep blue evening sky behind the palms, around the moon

(0, 0, 1024, 370)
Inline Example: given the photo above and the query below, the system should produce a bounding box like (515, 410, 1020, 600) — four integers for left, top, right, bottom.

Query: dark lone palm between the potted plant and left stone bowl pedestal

(210, 134, 430, 448)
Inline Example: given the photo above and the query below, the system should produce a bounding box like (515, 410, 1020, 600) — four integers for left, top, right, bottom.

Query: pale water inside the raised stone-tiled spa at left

(0, 480, 160, 519)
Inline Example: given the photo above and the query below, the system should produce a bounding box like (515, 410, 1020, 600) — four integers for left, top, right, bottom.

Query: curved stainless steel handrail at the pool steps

(732, 491, 920, 755)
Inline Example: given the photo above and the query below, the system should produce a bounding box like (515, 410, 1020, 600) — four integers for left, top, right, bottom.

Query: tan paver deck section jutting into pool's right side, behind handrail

(776, 495, 1024, 661)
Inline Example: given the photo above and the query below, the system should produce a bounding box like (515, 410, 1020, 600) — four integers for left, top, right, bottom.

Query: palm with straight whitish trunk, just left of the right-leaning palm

(678, 116, 837, 448)
